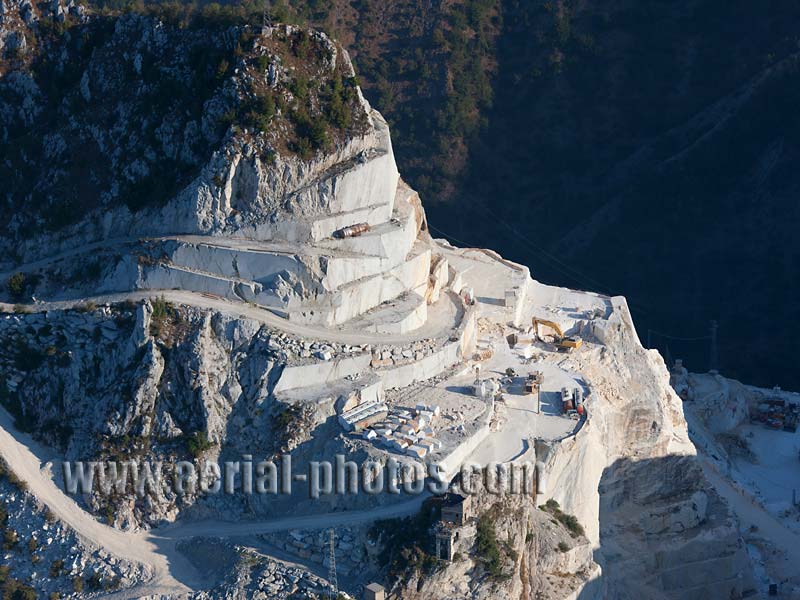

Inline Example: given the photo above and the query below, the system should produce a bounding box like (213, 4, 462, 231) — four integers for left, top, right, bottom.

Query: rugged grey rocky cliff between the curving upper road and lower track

(0, 292, 456, 528)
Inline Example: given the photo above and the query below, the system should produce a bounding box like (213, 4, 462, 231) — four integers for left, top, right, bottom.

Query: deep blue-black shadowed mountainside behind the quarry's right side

(429, 0, 800, 388)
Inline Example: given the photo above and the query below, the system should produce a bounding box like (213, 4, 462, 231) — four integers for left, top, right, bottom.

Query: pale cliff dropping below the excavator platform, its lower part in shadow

(386, 299, 755, 600)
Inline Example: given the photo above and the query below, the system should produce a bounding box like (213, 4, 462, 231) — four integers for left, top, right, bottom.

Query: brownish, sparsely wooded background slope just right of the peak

(340, 0, 502, 200)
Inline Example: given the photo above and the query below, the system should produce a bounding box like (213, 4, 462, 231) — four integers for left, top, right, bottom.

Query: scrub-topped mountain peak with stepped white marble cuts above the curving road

(0, 5, 418, 324)
